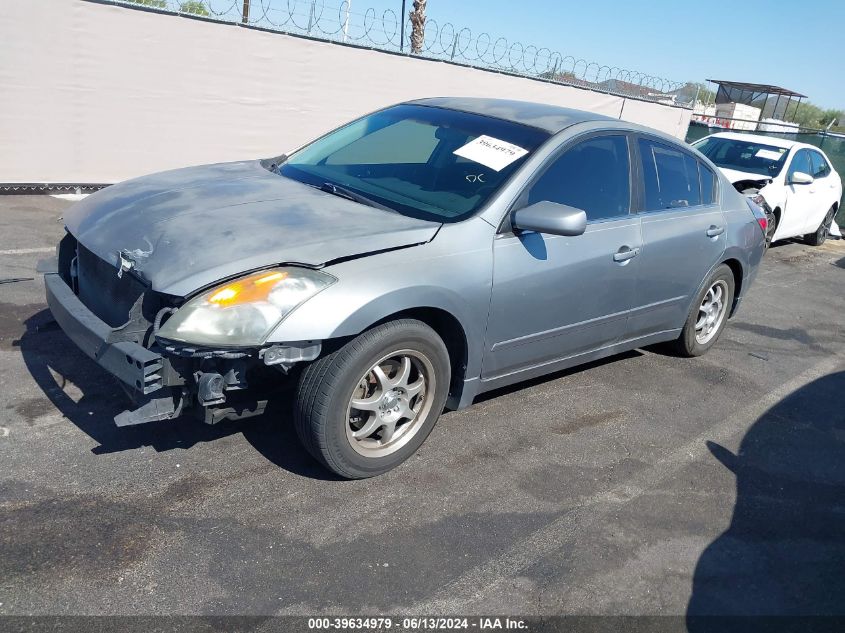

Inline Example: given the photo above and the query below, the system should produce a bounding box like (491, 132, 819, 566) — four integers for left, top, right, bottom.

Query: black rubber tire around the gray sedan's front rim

(293, 319, 451, 479)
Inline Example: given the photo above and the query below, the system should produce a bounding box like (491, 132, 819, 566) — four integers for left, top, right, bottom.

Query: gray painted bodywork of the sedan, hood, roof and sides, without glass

(57, 99, 764, 407)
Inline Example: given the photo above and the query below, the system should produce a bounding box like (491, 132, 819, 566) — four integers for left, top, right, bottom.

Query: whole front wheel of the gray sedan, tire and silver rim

(294, 319, 450, 479)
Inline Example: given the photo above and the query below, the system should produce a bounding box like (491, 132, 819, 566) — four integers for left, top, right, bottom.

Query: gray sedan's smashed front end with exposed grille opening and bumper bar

(39, 233, 321, 426)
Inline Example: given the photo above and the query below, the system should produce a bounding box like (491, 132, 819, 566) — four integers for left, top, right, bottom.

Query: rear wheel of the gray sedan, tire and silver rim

(674, 264, 734, 356)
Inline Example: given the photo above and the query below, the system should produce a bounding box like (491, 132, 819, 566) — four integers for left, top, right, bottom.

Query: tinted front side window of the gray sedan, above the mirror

(522, 135, 631, 221)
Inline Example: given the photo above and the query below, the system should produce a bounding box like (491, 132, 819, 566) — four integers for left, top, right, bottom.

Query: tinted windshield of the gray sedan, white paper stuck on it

(278, 105, 549, 222)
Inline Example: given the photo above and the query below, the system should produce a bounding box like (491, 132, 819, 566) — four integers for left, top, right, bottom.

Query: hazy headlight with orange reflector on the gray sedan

(158, 267, 337, 346)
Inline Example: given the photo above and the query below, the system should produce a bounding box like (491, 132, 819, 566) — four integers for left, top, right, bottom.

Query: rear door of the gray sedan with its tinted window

(626, 135, 726, 339)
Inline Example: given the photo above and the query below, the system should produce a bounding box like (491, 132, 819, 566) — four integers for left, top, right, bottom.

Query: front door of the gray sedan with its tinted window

(482, 133, 642, 380)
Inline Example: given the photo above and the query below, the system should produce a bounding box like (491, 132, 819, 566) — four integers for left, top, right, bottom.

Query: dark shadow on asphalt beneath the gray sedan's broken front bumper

(15, 310, 335, 479)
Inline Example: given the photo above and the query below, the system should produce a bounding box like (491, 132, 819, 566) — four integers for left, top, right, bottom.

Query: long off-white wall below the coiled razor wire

(0, 0, 690, 184)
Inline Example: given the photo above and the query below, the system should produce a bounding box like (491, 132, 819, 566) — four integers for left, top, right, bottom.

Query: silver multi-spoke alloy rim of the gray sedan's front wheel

(346, 349, 437, 457)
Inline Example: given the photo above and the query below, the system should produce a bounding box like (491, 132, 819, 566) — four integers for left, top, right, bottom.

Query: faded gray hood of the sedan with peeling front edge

(65, 161, 441, 296)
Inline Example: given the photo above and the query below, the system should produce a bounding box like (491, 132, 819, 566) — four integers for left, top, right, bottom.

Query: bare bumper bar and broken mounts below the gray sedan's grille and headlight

(44, 272, 321, 426)
